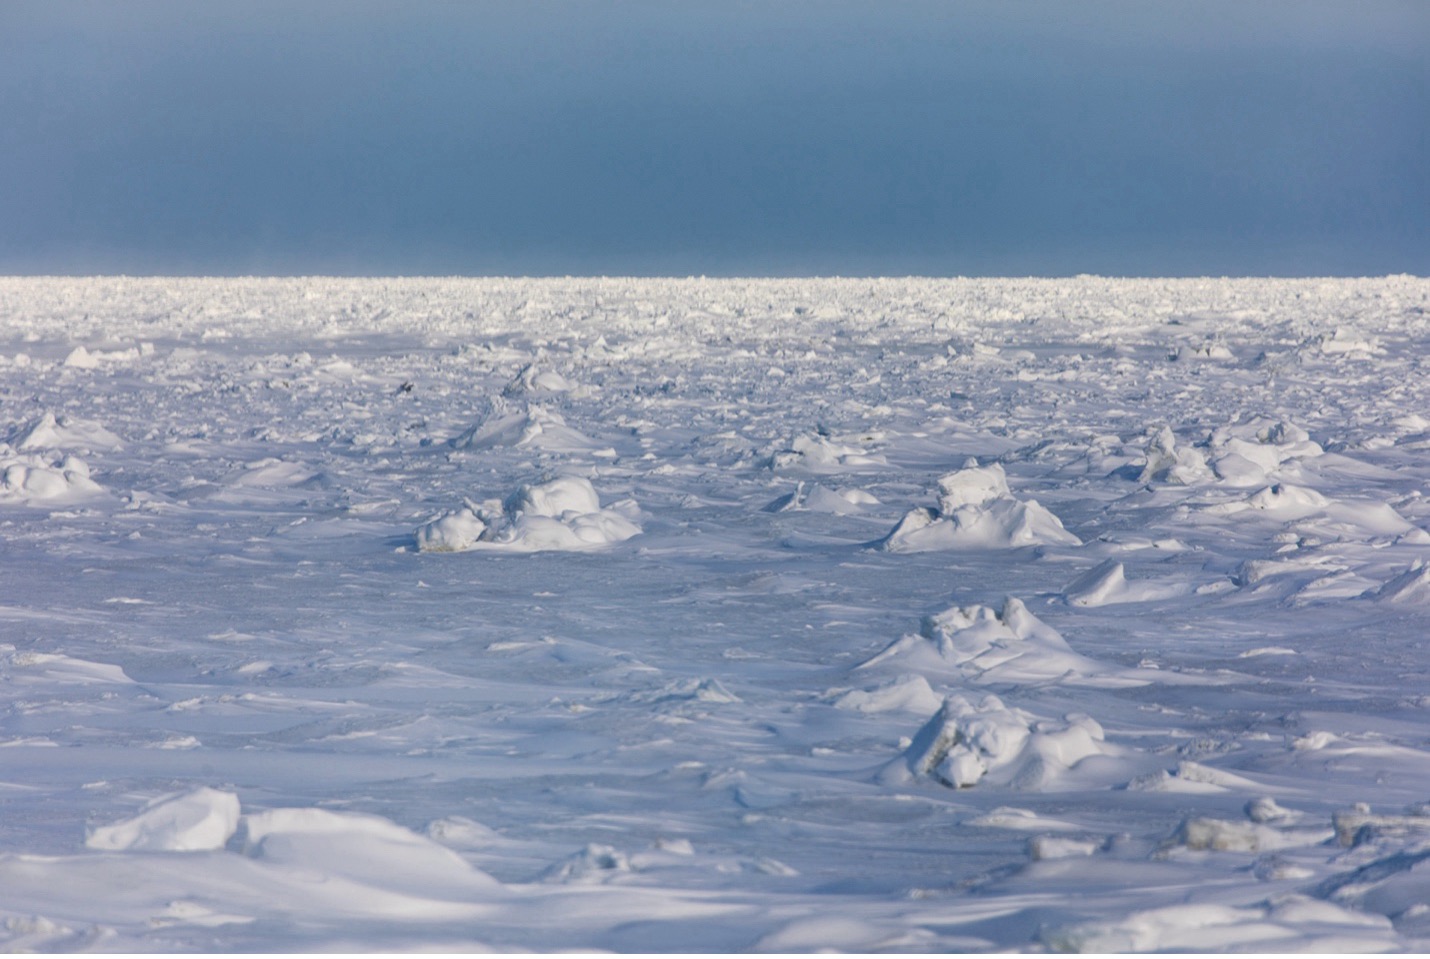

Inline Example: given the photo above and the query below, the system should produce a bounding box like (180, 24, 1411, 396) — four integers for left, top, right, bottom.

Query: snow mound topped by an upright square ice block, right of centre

(878, 463, 1083, 553)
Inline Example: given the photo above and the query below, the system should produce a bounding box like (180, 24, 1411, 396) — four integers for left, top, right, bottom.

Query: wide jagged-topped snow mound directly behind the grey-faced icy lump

(858, 596, 1135, 686)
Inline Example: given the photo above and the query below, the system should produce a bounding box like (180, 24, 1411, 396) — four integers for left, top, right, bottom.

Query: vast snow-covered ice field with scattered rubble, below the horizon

(0, 277, 1430, 950)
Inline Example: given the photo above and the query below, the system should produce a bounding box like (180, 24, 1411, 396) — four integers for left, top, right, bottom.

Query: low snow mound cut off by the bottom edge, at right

(1041, 896, 1399, 953)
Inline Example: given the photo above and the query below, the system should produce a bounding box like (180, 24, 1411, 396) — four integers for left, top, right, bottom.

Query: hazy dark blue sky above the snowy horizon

(0, 0, 1430, 276)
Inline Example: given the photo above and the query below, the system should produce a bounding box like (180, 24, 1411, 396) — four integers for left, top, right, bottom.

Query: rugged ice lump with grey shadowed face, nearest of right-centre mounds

(879, 696, 1117, 789)
